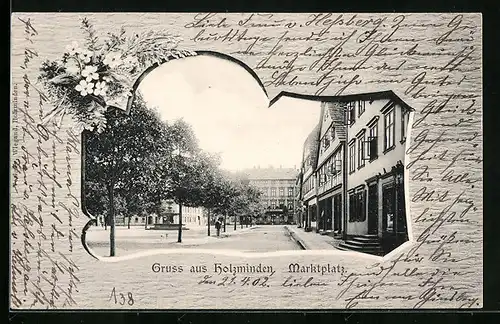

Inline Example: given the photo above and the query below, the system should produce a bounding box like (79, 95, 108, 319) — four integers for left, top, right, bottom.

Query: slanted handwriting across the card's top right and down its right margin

(184, 13, 483, 308)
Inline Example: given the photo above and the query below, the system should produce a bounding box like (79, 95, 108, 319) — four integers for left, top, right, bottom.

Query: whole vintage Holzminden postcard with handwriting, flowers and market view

(9, 12, 483, 310)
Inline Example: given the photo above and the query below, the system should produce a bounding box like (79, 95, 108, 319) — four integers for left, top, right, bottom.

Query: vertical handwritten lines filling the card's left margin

(10, 19, 80, 308)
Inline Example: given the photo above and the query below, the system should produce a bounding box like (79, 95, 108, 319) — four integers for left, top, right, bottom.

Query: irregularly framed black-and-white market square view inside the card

(84, 53, 413, 256)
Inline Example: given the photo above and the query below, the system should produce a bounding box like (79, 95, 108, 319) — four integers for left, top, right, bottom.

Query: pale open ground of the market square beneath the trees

(86, 225, 300, 256)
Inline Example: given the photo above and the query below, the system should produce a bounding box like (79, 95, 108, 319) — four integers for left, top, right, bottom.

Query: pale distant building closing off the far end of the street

(242, 167, 298, 224)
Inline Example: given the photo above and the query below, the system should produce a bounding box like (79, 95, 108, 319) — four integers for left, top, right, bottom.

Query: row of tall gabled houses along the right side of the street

(300, 91, 413, 253)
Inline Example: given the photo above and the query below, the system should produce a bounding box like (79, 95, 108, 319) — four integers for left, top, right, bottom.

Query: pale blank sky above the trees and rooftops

(138, 55, 320, 171)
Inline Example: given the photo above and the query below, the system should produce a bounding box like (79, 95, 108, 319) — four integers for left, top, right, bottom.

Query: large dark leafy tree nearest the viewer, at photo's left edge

(84, 97, 171, 256)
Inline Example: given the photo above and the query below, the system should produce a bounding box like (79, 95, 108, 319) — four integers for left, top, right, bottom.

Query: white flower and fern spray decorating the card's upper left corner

(39, 18, 196, 132)
